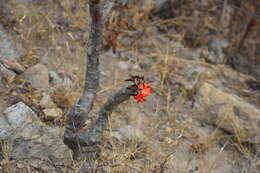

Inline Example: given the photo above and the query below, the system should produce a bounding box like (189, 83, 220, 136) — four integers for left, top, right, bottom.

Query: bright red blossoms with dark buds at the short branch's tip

(126, 76, 152, 102)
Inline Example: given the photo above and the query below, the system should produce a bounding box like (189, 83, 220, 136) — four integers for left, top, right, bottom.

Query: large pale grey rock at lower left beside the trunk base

(0, 102, 69, 172)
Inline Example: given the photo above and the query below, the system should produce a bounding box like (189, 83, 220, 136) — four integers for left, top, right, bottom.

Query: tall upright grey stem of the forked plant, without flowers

(64, 0, 114, 155)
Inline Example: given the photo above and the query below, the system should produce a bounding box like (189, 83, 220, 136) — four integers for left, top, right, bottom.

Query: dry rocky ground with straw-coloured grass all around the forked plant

(0, 0, 260, 173)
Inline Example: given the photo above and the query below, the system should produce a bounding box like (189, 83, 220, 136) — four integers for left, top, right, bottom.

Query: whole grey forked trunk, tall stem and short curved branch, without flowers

(64, 0, 136, 160)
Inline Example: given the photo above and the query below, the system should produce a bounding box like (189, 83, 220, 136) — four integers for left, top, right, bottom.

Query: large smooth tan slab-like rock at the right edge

(195, 83, 260, 144)
